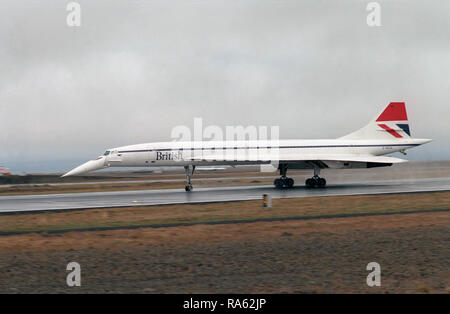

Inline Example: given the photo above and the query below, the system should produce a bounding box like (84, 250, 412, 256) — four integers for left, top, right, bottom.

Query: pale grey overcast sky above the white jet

(0, 0, 450, 171)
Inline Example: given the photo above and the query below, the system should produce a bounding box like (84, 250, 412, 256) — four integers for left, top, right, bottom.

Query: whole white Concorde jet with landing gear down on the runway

(63, 102, 431, 192)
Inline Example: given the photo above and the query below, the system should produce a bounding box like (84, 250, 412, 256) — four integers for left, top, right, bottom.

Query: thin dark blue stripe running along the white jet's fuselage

(119, 144, 420, 153)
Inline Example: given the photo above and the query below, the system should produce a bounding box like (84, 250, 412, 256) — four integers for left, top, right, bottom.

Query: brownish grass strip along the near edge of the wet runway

(0, 192, 450, 233)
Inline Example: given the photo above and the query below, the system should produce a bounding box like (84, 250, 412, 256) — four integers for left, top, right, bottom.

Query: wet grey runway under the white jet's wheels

(0, 178, 450, 213)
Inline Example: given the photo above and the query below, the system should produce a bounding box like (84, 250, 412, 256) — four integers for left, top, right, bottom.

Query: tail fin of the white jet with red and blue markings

(340, 102, 411, 140)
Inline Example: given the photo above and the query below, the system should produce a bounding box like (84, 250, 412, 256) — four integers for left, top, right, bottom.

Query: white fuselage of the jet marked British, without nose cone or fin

(102, 139, 427, 167)
